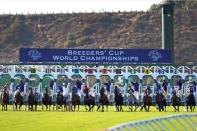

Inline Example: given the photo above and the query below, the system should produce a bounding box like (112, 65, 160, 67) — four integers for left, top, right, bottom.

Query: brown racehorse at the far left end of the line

(1, 86, 9, 111)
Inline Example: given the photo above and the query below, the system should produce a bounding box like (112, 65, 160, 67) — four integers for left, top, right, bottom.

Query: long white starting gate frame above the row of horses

(0, 64, 197, 103)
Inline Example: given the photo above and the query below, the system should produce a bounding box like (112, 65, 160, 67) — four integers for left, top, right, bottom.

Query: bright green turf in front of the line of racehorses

(0, 106, 197, 131)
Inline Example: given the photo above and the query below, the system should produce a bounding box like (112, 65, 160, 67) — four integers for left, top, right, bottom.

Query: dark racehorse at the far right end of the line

(186, 93, 196, 112)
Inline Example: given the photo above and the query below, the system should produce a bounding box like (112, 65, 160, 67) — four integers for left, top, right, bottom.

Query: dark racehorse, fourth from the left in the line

(42, 88, 52, 111)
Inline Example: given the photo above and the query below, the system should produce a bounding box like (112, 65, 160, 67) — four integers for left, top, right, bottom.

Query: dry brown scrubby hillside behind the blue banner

(0, 10, 197, 64)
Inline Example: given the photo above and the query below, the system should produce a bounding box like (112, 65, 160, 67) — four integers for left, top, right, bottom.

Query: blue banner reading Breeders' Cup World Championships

(19, 48, 171, 64)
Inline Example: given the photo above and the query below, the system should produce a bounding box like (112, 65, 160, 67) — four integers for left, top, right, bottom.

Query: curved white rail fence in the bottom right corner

(108, 114, 197, 131)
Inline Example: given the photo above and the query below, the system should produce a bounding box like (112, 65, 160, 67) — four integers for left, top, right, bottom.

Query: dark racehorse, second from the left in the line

(14, 91, 23, 111)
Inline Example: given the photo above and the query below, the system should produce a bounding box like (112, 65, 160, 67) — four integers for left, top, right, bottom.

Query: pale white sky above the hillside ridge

(0, 0, 160, 14)
